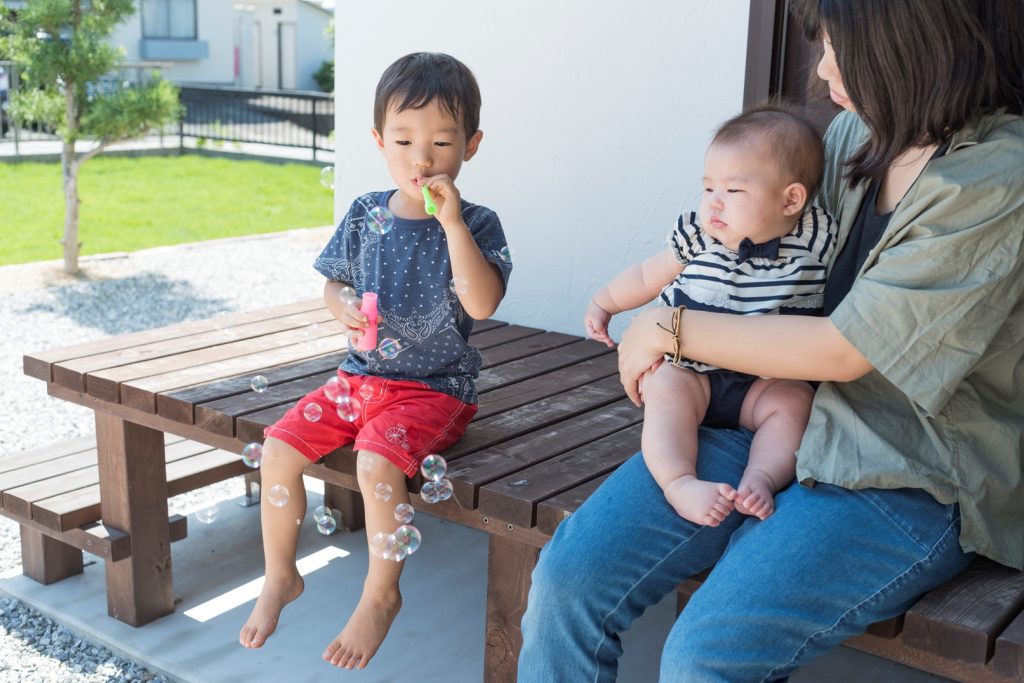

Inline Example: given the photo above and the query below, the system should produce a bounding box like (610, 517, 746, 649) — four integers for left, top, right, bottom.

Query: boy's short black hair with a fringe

(374, 52, 480, 139)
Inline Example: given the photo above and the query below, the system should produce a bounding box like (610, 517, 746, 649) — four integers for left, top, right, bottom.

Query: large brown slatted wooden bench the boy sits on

(18, 300, 1024, 682)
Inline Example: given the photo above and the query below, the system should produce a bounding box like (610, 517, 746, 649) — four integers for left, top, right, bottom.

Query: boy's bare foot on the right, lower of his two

(322, 588, 401, 669)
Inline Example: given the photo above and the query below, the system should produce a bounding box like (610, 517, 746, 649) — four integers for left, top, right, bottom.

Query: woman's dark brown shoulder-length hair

(793, 0, 1024, 184)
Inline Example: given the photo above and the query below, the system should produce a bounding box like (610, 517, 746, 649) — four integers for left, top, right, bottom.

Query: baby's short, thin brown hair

(712, 103, 824, 198)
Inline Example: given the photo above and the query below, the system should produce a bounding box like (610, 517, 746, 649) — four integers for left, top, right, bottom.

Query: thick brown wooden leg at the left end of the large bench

(96, 411, 174, 626)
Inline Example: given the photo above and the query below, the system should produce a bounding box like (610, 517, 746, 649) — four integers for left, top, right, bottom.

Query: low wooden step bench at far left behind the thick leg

(0, 434, 248, 585)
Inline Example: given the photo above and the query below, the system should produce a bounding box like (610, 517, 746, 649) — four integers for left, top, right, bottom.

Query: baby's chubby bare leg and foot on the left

(641, 362, 735, 526)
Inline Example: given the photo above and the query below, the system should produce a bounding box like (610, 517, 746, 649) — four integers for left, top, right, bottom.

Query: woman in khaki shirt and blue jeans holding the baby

(519, 0, 1024, 683)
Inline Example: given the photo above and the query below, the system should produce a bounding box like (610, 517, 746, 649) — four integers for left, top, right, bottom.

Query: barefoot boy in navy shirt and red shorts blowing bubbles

(239, 53, 512, 669)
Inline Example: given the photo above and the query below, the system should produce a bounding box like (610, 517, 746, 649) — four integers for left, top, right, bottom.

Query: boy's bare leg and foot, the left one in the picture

(239, 437, 309, 647)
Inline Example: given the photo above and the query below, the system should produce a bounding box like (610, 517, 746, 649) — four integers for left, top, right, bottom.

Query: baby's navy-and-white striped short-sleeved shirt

(659, 206, 839, 373)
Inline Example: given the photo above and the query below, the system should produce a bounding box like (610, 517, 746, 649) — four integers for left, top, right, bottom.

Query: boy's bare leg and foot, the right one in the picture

(323, 451, 409, 669)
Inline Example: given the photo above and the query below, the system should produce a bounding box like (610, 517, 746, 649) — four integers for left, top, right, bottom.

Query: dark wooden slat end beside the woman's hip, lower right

(903, 558, 1024, 666)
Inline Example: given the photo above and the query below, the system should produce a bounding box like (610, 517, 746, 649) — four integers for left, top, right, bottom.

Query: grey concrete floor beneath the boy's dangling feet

(0, 480, 943, 683)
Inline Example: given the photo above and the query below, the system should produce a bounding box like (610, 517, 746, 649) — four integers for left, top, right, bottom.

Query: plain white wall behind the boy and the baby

(335, 0, 750, 339)
